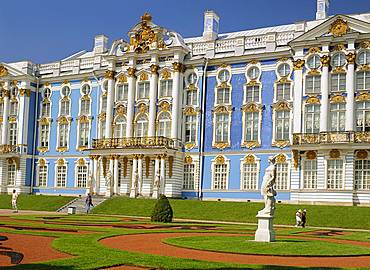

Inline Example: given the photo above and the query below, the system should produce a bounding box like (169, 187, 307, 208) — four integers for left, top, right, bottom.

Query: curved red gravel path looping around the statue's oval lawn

(100, 233, 370, 267)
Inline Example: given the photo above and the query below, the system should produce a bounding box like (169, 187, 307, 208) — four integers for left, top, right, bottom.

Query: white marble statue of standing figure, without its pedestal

(258, 157, 277, 216)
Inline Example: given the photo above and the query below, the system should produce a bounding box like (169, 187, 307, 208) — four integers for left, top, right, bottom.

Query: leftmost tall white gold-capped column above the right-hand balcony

(293, 59, 304, 133)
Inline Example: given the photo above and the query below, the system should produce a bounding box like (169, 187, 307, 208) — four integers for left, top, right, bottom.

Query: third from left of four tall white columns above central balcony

(148, 65, 159, 137)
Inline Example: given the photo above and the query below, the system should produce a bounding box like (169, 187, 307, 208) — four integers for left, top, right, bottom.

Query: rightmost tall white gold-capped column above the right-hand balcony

(346, 53, 356, 131)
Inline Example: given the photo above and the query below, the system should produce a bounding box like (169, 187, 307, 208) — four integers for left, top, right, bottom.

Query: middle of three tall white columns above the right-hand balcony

(320, 55, 330, 132)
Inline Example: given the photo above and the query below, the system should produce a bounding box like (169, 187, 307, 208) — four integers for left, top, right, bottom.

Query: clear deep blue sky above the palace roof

(0, 0, 370, 63)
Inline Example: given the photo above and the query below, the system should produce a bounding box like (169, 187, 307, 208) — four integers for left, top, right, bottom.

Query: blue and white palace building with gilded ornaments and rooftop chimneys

(0, 0, 370, 205)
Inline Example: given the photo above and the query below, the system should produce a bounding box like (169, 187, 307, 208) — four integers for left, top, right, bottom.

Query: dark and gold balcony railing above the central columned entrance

(92, 136, 182, 150)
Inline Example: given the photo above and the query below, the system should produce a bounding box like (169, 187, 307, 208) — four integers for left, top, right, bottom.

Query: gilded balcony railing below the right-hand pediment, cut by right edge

(293, 131, 370, 145)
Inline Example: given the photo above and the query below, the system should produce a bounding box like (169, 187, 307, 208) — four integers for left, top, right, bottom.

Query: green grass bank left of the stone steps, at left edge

(0, 195, 76, 212)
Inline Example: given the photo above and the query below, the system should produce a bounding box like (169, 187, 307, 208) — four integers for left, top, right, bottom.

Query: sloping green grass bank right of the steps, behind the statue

(92, 198, 370, 229)
